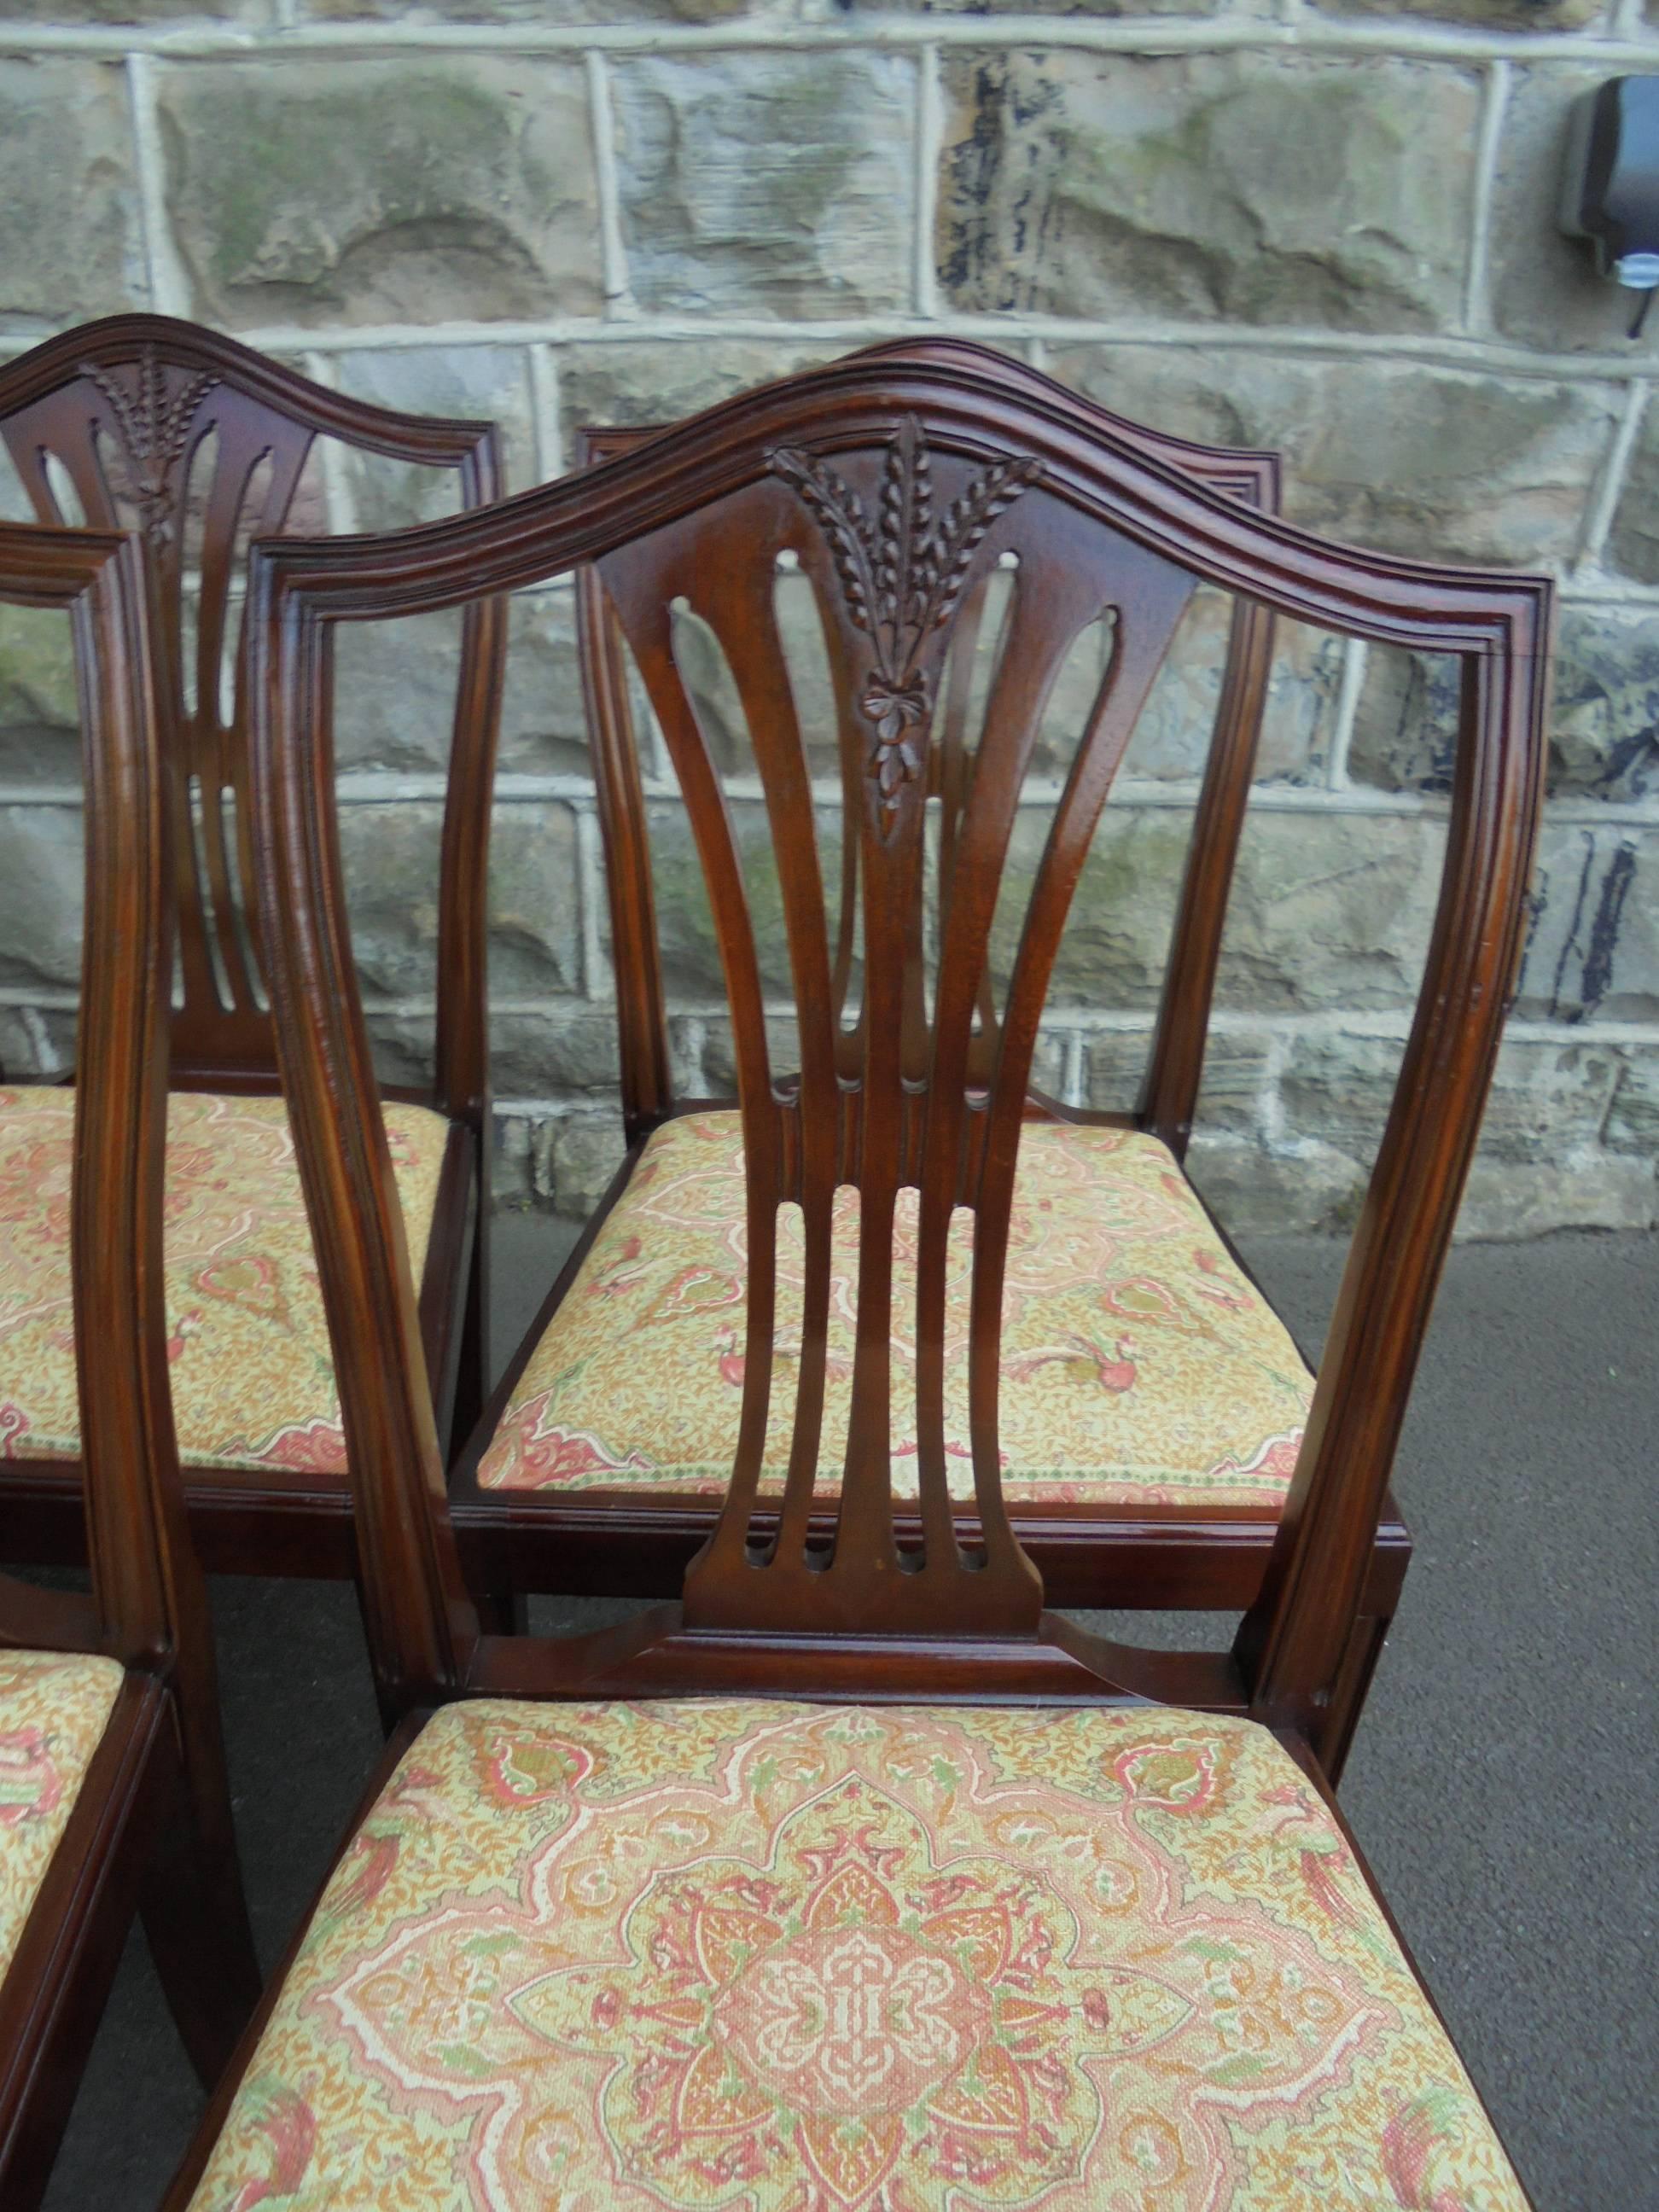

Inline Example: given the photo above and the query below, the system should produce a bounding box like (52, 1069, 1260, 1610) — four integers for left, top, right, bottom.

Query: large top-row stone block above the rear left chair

(160, 53, 599, 325)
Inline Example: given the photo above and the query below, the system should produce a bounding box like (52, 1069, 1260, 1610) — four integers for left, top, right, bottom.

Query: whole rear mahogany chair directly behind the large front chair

(453, 339, 1412, 1774)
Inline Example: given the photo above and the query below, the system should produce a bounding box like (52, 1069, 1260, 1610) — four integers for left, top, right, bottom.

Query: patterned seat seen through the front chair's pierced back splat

(478, 1113, 1312, 1509)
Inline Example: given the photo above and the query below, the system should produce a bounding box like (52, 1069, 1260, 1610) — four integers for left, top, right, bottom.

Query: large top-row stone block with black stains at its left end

(938, 51, 1477, 329)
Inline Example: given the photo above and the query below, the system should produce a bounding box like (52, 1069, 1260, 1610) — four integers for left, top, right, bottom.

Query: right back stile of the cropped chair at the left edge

(0, 524, 217, 1690)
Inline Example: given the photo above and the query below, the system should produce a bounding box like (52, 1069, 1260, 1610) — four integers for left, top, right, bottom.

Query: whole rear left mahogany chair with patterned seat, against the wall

(0, 314, 504, 1577)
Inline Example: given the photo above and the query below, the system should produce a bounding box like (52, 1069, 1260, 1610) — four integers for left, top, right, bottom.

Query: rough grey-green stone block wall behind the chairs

(0, 0, 1659, 1234)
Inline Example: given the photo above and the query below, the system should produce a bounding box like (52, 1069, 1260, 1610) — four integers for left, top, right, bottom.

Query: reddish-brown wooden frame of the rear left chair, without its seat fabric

(0, 314, 507, 1575)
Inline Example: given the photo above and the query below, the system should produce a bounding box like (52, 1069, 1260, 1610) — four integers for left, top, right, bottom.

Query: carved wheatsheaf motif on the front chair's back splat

(767, 416, 1042, 830)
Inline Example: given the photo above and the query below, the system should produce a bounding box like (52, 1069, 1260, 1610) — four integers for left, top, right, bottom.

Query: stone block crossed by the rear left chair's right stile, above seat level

(341, 800, 582, 1000)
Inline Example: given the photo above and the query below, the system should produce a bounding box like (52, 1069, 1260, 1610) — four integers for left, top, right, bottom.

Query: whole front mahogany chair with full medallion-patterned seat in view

(168, 358, 1551, 2212)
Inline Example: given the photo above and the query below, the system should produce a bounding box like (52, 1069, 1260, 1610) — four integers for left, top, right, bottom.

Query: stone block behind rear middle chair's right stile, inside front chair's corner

(1124, 588, 1342, 783)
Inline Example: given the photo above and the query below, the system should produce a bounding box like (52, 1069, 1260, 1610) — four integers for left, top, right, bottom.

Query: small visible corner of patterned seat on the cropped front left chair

(0, 1650, 122, 1973)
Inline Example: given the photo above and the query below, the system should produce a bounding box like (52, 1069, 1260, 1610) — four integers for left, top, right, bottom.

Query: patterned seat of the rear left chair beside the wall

(0, 1086, 449, 1473)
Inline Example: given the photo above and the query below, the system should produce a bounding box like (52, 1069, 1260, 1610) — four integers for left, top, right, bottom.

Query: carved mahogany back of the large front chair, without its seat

(250, 356, 1551, 1712)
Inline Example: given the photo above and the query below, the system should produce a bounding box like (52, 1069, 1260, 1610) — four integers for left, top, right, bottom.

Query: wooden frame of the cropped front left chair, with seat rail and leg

(0, 524, 259, 2208)
